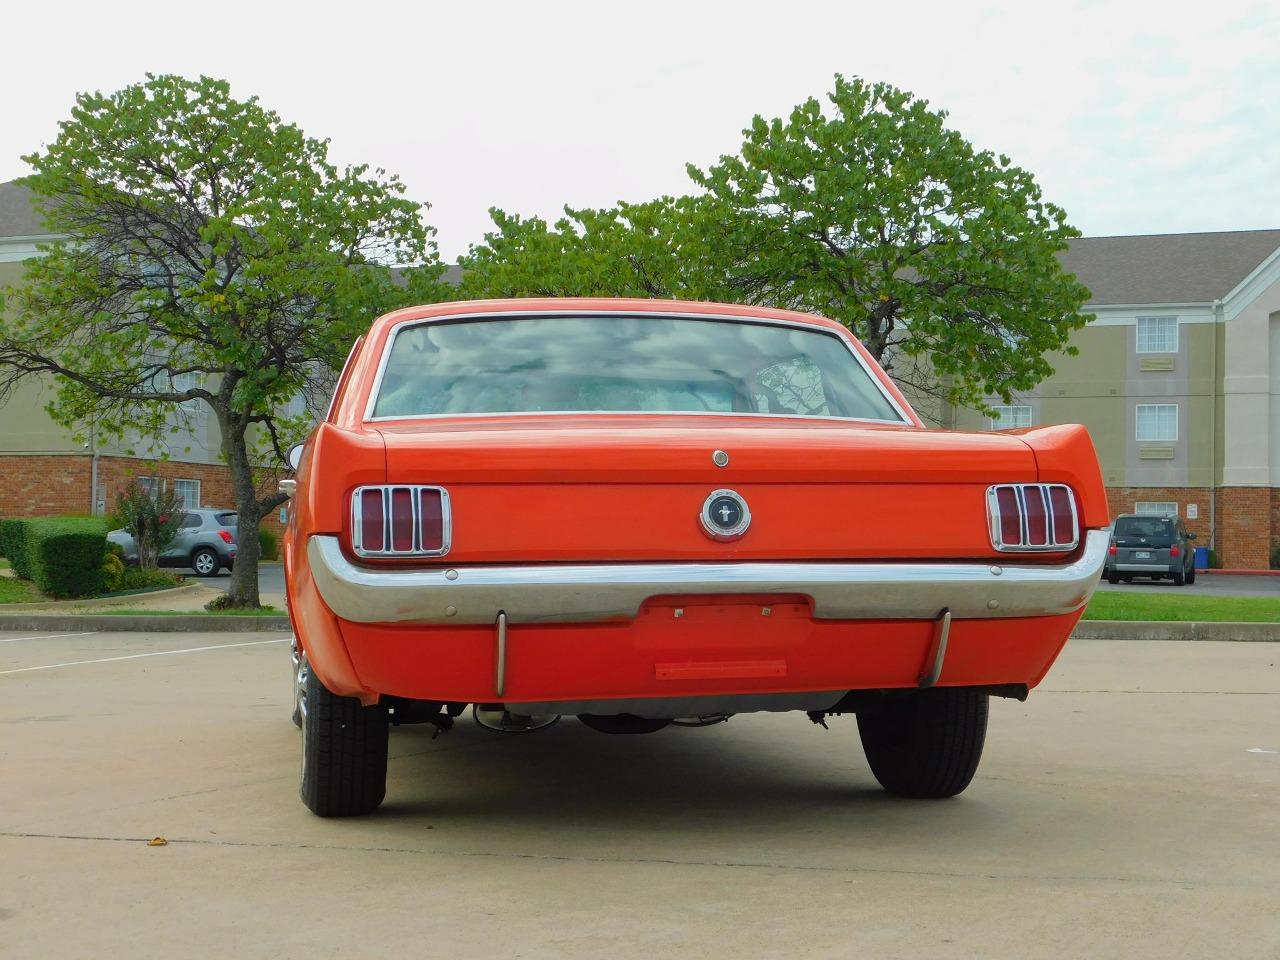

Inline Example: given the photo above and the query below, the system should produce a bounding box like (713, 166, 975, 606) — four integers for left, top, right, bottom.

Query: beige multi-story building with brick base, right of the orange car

(945, 230, 1280, 568)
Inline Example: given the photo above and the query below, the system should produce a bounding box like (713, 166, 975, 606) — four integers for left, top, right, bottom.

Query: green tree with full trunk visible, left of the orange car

(0, 74, 439, 607)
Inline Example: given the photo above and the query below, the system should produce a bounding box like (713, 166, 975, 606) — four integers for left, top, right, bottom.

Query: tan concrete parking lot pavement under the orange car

(0, 634, 1280, 960)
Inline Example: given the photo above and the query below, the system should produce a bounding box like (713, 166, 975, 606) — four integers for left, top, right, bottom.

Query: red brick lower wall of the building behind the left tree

(0, 454, 284, 536)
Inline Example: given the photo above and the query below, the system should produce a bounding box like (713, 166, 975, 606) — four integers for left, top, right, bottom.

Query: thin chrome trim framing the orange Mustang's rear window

(364, 308, 915, 426)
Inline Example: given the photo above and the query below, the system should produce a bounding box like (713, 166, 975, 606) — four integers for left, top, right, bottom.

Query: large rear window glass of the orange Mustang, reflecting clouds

(372, 316, 902, 422)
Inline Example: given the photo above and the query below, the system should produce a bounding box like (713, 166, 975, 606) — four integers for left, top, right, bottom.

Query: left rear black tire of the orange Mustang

(301, 669, 388, 817)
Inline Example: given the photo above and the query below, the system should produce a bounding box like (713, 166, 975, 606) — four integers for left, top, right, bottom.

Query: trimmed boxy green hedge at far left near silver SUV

(4, 517, 106, 598)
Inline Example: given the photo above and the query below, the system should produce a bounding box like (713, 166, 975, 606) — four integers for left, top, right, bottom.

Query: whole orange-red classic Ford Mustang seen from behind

(284, 300, 1108, 817)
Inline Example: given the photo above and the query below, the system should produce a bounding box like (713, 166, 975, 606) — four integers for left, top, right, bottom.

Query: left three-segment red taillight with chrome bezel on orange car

(351, 484, 449, 557)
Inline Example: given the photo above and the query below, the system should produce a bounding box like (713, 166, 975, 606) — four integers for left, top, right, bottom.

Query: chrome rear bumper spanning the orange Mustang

(307, 530, 1110, 626)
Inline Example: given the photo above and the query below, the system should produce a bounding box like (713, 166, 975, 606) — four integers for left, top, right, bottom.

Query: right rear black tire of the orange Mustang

(858, 687, 989, 799)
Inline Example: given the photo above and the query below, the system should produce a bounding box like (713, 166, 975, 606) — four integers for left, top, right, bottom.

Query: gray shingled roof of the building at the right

(1061, 230, 1280, 303)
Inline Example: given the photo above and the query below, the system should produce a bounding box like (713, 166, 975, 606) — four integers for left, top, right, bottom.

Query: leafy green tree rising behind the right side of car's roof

(687, 74, 1088, 404)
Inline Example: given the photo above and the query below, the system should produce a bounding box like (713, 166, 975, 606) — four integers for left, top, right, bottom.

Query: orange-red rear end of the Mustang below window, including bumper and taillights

(287, 305, 1107, 713)
